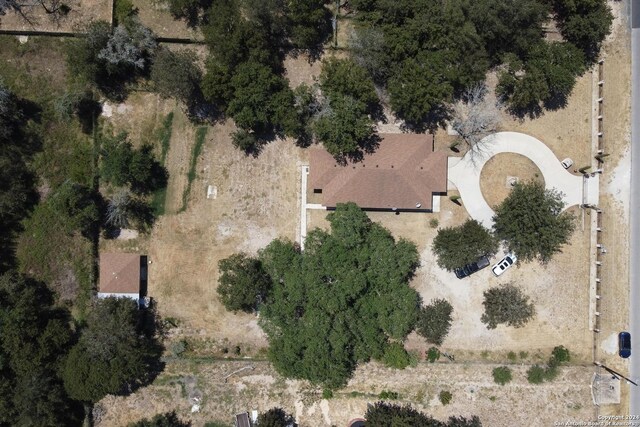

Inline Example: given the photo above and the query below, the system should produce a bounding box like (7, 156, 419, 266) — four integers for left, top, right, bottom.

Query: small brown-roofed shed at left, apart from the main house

(98, 253, 147, 305)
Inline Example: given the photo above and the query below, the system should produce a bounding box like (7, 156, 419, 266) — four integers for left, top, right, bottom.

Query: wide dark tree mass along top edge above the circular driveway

(349, 0, 611, 122)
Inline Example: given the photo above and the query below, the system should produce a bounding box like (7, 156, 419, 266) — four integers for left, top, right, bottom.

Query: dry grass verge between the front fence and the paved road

(596, 2, 632, 415)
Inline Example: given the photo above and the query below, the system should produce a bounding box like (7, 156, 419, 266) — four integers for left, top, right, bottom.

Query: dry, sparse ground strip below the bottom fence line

(97, 360, 594, 427)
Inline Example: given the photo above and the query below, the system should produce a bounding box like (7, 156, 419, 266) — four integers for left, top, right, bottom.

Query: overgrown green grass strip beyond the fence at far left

(0, 36, 95, 316)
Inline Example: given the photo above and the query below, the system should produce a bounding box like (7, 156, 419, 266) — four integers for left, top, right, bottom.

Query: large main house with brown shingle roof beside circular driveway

(308, 134, 447, 212)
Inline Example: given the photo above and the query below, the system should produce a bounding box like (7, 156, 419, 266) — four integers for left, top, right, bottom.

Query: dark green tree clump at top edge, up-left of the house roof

(192, 0, 331, 147)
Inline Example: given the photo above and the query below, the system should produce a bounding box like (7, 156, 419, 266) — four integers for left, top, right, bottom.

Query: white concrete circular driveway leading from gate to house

(449, 132, 599, 228)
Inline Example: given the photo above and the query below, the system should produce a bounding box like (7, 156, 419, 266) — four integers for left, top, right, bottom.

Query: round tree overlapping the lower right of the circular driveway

(493, 181, 575, 263)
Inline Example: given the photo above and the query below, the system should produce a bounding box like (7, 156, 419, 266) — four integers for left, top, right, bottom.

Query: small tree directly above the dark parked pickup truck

(432, 219, 498, 271)
